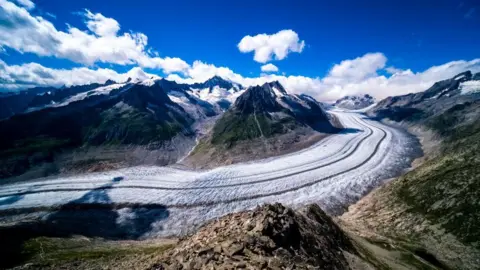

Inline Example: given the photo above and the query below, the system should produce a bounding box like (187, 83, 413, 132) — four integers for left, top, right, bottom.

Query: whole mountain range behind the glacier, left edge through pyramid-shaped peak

(0, 76, 335, 178)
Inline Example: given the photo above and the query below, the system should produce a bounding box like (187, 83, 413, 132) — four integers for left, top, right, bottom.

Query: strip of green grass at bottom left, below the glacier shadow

(0, 233, 175, 269)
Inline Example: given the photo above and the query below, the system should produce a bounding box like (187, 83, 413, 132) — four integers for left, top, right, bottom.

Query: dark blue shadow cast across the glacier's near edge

(42, 177, 169, 239)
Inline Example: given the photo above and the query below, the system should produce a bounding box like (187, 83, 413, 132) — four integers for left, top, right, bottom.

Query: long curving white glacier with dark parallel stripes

(0, 111, 420, 238)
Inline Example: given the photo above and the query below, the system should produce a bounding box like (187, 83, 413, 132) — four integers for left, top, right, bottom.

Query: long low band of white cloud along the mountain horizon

(0, 53, 480, 101)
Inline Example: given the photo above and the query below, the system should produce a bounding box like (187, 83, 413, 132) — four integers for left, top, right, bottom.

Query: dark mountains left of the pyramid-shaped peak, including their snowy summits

(0, 77, 248, 178)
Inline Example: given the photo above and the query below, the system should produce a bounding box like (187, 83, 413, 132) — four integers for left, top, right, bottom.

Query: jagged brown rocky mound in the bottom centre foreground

(151, 204, 357, 269)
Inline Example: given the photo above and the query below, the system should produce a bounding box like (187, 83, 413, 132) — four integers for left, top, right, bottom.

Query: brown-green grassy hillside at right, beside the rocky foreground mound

(341, 101, 480, 269)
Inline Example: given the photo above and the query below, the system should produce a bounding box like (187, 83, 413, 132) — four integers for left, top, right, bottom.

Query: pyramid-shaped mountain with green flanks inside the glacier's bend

(186, 82, 336, 167)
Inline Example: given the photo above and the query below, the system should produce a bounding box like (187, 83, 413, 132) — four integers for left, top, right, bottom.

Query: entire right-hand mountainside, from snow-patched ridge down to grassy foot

(342, 72, 480, 269)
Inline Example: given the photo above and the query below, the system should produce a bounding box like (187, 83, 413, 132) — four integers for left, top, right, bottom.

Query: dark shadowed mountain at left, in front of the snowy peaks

(0, 83, 194, 178)
